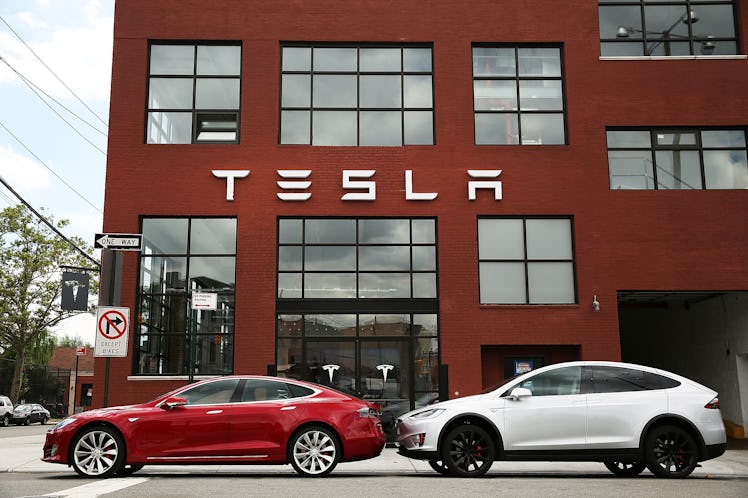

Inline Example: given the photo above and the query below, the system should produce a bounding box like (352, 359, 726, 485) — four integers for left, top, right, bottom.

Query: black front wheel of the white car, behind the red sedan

(441, 424, 496, 477)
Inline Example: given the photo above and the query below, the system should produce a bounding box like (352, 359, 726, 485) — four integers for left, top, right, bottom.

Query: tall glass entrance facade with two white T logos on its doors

(276, 218, 439, 440)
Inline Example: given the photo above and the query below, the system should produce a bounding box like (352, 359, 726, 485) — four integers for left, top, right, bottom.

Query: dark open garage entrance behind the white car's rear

(618, 291, 748, 439)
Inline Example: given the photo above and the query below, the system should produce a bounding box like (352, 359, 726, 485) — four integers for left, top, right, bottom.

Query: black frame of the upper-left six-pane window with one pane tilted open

(143, 40, 243, 145)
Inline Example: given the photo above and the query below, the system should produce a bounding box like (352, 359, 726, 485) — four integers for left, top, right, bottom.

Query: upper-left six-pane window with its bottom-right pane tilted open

(146, 43, 241, 144)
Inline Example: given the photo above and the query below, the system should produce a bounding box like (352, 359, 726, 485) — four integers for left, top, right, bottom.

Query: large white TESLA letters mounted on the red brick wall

(211, 169, 502, 202)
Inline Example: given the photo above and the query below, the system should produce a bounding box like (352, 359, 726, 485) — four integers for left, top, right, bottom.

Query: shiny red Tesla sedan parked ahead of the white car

(42, 376, 385, 477)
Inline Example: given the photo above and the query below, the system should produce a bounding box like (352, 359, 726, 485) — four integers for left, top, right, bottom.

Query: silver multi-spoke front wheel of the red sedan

(70, 426, 125, 478)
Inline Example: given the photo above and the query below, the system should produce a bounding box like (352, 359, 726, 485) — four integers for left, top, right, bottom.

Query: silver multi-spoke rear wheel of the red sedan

(287, 426, 341, 477)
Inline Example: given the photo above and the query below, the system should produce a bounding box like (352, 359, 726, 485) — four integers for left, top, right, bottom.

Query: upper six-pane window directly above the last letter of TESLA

(473, 45, 566, 145)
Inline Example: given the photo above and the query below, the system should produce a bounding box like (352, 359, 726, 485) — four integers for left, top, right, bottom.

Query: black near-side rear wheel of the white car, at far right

(644, 425, 699, 479)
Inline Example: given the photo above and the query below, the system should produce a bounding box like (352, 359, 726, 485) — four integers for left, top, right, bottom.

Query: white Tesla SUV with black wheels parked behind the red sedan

(397, 361, 727, 477)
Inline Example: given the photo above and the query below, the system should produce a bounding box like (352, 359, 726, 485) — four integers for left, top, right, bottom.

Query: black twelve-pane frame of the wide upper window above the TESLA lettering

(278, 42, 436, 147)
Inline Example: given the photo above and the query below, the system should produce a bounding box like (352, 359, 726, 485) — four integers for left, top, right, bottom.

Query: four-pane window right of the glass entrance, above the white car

(478, 217, 576, 304)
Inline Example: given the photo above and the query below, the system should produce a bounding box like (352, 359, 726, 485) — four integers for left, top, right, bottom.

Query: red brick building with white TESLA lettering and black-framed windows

(94, 0, 748, 442)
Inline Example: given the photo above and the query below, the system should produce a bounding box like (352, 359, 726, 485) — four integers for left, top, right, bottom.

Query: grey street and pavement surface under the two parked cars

(0, 425, 748, 497)
